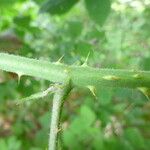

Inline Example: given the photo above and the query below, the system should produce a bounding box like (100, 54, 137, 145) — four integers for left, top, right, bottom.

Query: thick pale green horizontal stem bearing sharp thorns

(0, 53, 150, 88)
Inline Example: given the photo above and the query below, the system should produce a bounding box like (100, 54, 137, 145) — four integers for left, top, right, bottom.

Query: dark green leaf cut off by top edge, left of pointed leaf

(40, 0, 78, 15)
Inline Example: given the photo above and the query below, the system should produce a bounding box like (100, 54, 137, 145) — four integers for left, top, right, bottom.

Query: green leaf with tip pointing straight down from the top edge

(85, 0, 111, 25)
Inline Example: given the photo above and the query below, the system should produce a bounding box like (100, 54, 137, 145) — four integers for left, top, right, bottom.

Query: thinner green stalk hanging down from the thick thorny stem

(48, 83, 71, 150)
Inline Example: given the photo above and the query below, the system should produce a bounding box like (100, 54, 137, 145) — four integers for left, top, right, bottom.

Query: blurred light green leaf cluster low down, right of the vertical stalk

(63, 105, 99, 150)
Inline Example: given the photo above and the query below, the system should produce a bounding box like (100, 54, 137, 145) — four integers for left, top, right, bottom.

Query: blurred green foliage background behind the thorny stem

(0, 0, 150, 150)
